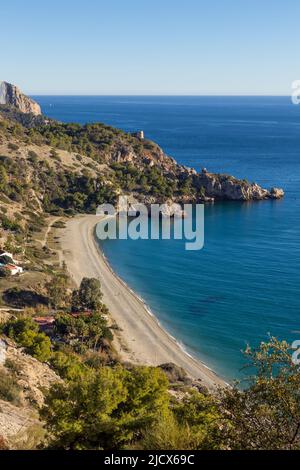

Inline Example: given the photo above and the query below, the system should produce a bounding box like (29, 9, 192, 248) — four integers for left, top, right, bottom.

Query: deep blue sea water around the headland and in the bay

(35, 96, 300, 379)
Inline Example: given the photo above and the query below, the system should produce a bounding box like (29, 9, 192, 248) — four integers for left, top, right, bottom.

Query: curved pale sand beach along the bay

(61, 215, 225, 389)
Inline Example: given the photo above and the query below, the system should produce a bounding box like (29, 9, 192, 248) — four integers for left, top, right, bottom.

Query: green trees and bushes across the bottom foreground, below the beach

(38, 338, 300, 450)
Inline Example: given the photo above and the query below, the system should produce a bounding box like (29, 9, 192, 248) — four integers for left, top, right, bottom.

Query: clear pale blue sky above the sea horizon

(0, 0, 300, 95)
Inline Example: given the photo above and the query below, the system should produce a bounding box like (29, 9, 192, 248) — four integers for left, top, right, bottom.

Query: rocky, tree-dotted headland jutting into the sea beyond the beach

(0, 82, 284, 213)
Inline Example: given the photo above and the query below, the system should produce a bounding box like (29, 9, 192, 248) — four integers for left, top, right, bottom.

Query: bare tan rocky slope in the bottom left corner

(0, 336, 61, 449)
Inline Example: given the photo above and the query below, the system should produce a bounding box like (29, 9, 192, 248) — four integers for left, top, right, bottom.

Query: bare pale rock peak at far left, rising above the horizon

(0, 82, 42, 116)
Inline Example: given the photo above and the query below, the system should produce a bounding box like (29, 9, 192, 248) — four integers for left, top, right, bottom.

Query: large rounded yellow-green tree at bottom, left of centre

(41, 366, 169, 450)
